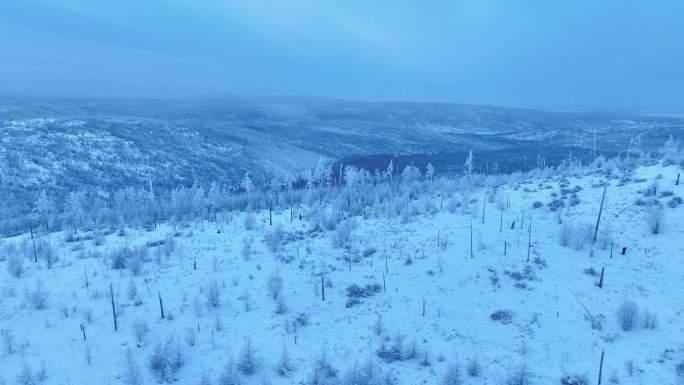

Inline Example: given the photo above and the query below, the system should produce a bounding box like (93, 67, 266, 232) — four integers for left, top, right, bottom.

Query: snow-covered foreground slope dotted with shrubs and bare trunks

(0, 162, 684, 385)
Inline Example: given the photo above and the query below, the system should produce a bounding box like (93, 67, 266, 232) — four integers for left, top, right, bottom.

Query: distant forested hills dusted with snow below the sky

(0, 97, 684, 202)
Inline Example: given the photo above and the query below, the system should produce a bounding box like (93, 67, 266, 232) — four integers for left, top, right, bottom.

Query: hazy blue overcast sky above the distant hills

(0, 0, 684, 113)
